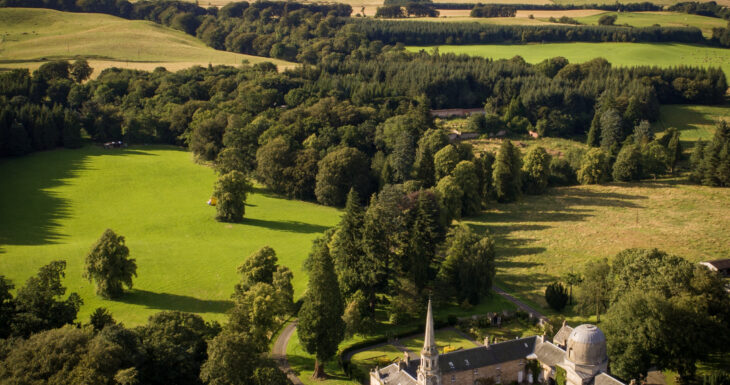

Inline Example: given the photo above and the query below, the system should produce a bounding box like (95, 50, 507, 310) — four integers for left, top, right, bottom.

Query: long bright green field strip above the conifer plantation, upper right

(407, 43, 730, 75)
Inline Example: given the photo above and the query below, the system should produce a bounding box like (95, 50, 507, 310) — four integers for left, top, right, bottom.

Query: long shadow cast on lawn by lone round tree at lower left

(117, 289, 233, 313)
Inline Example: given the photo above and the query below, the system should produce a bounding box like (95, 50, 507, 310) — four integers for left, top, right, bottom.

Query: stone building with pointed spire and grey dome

(370, 301, 624, 385)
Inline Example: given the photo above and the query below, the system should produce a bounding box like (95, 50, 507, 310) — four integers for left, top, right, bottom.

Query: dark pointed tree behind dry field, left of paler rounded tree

(492, 140, 522, 202)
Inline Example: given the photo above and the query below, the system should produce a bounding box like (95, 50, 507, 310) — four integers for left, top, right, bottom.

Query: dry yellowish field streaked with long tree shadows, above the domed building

(466, 178, 730, 310)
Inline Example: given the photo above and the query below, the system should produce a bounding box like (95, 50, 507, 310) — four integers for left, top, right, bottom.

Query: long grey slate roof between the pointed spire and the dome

(407, 336, 537, 377)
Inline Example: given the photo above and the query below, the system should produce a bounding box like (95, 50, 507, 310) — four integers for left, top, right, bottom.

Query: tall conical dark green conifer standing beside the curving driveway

(297, 238, 345, 378)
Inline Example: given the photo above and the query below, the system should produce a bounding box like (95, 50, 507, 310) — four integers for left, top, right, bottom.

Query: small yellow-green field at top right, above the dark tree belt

(576, 12, 728, 37)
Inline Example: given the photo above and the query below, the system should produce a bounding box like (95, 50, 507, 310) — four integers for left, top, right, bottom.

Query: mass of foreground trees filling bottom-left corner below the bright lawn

(0, 243, 295, 385)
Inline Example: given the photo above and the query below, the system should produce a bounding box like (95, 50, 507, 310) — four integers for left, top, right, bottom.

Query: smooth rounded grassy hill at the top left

(0, 8, 293, 74)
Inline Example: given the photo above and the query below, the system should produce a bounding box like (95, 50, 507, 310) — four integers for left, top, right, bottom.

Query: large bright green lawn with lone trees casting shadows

(0, 146, 340, 326)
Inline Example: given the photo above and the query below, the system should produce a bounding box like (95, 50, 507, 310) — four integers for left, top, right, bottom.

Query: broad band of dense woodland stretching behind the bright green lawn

(0, 53, 727, 195)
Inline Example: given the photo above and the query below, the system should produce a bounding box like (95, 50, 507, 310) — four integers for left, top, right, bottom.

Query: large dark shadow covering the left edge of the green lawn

(0, 146, 154, 249)
